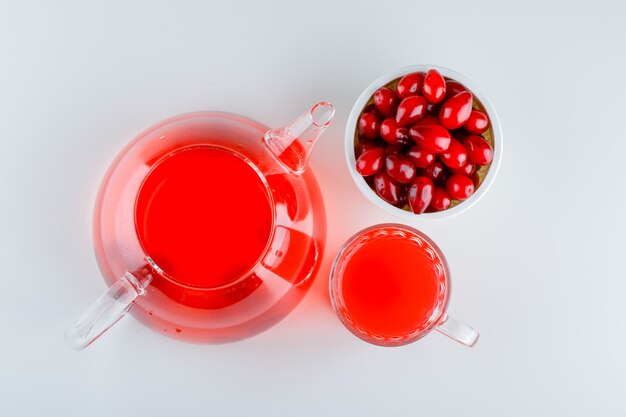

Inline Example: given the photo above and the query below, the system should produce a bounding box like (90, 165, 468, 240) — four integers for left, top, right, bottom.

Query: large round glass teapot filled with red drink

(66, 102, 334, 349)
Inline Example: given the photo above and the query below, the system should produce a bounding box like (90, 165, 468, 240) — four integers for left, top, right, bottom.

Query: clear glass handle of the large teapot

(65, 272, 145, 350)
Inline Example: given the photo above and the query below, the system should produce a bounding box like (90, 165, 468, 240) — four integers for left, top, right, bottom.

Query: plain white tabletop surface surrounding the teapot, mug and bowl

(0, 0, 626, 416)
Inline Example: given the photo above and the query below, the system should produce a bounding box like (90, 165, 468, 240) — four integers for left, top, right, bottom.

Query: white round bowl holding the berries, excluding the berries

(345, 65, 502, 221)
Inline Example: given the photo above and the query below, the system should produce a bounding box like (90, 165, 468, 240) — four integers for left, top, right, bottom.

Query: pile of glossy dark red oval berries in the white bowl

(355, 69, 493, 214)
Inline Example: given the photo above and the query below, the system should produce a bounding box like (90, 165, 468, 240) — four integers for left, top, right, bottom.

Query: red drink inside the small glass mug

(338, 228, 447, 339)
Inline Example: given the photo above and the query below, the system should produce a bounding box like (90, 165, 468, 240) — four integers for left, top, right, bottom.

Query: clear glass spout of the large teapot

(263, 102, 335, 175)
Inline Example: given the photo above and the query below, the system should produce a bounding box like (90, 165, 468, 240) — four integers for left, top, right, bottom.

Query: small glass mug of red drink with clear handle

(329, 223, 478, 347)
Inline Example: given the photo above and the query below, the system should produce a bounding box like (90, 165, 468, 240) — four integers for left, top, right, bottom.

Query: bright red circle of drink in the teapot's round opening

(135, 146, 273, 288)
